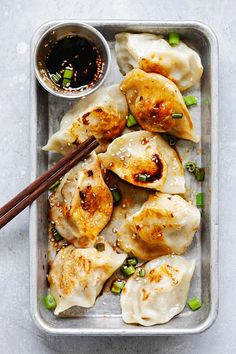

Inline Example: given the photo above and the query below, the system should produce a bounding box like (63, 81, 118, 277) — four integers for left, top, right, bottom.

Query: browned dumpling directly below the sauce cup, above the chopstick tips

(43, 85, 128, 155)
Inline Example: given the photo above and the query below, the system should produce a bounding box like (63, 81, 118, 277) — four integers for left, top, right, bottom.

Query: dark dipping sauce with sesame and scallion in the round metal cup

(46, 36, 104, 91)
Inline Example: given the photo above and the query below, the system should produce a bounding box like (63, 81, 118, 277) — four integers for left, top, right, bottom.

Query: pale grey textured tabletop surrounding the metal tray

(0, 0, 236, 354)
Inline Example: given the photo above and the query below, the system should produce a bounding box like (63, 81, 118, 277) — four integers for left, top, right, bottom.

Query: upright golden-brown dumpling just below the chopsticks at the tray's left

(49, 152, 113, 247)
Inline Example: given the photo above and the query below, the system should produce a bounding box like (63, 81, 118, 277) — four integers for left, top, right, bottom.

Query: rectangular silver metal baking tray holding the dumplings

(30, 20, 218, 336)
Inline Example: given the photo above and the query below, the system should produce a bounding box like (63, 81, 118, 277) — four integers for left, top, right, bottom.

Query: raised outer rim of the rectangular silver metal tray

(29, 19, 219, 336)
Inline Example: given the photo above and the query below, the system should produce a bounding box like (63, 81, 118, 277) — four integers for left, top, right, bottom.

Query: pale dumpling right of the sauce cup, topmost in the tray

(115, 33, 203, 91)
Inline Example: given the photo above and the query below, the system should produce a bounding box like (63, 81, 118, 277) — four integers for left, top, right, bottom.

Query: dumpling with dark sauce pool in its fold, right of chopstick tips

(99, 130, 185, 194)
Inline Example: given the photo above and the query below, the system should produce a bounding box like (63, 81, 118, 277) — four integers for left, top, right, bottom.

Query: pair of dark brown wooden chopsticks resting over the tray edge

(0, 136, 99, 229)
